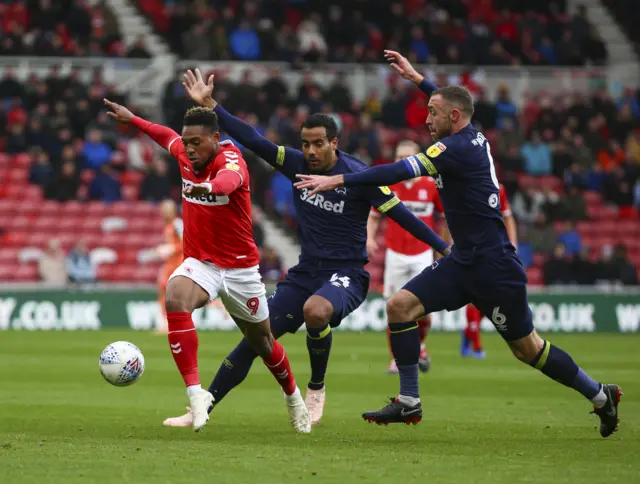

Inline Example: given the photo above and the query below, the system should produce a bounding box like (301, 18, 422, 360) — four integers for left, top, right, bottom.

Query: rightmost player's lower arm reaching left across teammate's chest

(295, 158, 418, 194)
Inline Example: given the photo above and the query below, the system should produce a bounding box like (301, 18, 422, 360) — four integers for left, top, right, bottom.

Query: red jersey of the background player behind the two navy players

(385, 177, 444, 255)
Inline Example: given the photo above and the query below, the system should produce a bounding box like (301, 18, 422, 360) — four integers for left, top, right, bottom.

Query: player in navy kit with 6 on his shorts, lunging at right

(296, 51, 622, 437)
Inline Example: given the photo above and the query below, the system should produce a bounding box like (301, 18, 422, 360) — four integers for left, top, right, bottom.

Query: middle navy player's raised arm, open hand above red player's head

(182, 69, 285, 168)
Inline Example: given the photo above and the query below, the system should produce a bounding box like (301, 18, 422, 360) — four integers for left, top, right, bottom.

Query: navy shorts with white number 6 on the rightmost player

(403, 254, 533, 341)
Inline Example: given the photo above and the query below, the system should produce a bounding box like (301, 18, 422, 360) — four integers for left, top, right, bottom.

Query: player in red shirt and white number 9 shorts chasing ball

(104, 99, 311, 433)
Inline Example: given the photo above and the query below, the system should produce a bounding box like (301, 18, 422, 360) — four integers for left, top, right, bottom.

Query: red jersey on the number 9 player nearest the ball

(168, 137, 260, 269)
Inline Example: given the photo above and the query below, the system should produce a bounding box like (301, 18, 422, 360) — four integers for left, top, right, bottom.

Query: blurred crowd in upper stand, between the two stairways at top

(138, 0, 608, 66)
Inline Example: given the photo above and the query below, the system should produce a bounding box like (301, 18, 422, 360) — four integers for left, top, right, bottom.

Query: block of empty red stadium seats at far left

(0, 154, 164, 282)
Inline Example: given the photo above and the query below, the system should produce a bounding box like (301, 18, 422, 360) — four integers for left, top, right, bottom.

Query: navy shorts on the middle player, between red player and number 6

(268, 265, 370, 337)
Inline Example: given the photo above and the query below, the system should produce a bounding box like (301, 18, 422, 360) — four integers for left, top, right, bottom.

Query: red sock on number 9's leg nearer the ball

(167, 313, 200, 386)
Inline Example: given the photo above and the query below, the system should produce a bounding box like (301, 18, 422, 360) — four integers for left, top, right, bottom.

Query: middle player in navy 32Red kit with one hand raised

(168, 70, 449, 425)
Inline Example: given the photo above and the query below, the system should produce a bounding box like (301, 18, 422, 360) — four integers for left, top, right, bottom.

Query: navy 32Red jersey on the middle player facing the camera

(276, 146, 400, 263)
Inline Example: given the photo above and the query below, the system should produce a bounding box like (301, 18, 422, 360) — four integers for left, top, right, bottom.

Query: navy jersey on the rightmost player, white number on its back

(403, 124, 515, 263)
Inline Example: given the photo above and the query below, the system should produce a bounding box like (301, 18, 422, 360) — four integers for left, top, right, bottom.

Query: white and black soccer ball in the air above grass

(98, 341, 144, 387)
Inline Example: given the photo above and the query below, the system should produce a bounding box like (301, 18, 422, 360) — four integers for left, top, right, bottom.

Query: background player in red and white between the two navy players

(367, 141, 443, 373)
